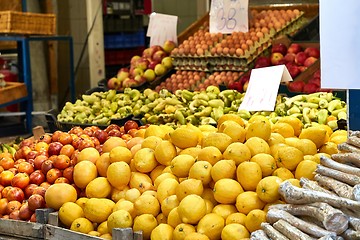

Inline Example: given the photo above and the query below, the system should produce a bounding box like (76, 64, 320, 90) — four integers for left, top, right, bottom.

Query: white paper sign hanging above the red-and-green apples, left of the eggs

(146, 13, 178, 46)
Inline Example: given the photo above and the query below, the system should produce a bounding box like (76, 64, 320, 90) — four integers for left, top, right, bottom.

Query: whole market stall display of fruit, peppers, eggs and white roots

(0, 1, 360, 240)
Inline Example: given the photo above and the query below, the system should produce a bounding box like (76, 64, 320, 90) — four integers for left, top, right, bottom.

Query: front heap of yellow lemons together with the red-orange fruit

(0, 114, 347, 240)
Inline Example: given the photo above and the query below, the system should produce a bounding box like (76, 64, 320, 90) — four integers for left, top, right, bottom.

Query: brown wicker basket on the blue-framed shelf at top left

(0, 11, 56, 35)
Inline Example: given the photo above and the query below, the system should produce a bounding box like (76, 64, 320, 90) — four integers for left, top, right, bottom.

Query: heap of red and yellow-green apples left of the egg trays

(107, 40, 176, 90)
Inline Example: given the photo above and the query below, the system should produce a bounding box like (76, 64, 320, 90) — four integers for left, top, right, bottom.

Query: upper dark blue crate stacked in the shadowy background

(104, 30, 145, 49)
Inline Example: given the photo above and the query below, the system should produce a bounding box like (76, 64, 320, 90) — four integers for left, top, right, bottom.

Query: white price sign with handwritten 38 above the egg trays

(210, 0, 249, 34)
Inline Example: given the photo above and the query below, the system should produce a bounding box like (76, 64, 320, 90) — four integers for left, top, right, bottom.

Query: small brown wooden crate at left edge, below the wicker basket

(0, 82, 27, 104)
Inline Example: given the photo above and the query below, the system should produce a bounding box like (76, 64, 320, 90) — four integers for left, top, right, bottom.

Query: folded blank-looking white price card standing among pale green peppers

(239, 65, 292, 111)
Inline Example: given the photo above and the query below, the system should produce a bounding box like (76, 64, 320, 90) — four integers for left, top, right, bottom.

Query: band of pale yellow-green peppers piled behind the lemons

(57, 86, 347, 129)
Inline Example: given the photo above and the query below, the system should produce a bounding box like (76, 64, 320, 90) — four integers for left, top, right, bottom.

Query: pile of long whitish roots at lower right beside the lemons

(250, 132, 360, 240)
